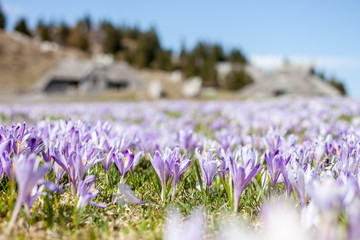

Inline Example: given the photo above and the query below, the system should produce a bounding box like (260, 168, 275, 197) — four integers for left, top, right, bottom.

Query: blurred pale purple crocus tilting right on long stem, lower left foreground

(9, 155, 51, 229)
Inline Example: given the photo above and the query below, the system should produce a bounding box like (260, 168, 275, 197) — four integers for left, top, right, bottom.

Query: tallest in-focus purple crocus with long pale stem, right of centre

(229, 147, 262, 212)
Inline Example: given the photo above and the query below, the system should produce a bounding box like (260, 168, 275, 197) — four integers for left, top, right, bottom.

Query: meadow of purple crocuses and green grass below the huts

(0, 98, 360, 239)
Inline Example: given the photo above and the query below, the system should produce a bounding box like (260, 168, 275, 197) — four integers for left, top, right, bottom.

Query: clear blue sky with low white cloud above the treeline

(0, 0, 360, 98)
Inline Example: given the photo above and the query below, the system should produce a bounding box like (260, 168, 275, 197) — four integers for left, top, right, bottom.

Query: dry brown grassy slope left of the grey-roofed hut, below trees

(0, 30, 86, 94)
